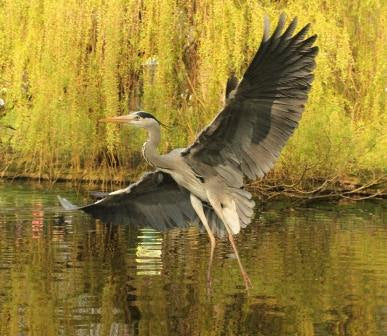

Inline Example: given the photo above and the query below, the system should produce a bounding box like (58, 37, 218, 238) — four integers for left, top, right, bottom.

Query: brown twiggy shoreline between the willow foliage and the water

(0, 171, 387, 203)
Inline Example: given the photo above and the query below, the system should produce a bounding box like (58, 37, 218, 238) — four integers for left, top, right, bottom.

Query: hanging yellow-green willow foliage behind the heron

(0, 0, 387, 179)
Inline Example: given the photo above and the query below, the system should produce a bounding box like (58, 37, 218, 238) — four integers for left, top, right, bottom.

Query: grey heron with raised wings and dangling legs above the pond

(59, 14, 318, 289)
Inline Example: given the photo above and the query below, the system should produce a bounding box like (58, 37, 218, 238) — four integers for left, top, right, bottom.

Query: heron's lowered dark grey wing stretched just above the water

(58, 171, 222, 232)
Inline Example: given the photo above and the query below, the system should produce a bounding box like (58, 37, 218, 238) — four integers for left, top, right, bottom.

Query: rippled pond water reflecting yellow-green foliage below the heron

(0, 182, 387, 336)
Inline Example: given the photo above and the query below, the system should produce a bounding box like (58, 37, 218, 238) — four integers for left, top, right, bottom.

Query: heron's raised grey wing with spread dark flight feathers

(182, 14, 318, 187)
